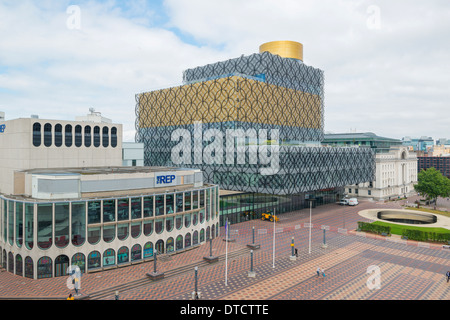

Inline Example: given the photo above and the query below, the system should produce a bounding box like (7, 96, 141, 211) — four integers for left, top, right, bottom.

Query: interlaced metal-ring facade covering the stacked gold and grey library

(136, 52, 375, 194)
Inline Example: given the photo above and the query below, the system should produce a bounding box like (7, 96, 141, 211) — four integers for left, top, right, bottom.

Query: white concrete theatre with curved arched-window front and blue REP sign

(0, 114, 219, 278)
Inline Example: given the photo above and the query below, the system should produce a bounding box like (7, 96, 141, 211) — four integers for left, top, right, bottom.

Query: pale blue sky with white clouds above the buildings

(0, 0, 450, 141)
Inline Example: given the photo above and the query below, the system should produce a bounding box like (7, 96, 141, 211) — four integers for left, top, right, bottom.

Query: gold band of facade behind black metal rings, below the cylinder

(137, 76, 323, 129)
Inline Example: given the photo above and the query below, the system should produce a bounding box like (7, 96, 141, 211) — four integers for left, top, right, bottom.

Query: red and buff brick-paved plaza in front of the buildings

(0, 199, 450, 300)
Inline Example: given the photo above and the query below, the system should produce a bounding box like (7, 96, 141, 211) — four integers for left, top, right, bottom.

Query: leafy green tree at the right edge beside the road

(414, 167, 450, 209)
